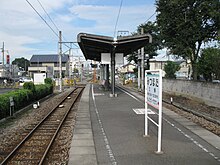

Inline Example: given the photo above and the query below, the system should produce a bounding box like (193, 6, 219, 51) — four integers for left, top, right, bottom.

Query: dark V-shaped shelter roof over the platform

(77, 33, 152, 61)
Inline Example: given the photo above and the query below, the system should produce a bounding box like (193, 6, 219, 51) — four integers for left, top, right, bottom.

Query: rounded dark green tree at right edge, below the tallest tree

(198, 47, 220, 81)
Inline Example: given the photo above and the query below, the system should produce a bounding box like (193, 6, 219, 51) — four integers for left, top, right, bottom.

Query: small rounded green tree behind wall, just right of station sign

(164, 61, 180, 79)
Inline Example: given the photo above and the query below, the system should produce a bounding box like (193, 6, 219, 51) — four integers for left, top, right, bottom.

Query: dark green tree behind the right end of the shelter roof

(127, 21, 162, 69)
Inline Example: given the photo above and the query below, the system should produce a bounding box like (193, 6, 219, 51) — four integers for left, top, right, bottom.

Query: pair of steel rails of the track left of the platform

(0, 87, 84, 165)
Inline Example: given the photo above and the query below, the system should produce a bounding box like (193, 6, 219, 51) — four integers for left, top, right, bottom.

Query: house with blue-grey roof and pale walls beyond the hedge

(28, 54, 69, 78)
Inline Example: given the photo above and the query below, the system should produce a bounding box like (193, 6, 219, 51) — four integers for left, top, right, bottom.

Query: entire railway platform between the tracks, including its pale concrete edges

(69, 84, 220, 165)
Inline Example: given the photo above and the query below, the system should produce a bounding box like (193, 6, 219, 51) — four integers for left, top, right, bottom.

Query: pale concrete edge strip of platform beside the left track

(68, 85, 97, 165)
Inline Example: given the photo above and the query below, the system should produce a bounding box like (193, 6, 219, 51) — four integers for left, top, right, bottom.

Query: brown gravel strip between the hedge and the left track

(0, 90, 74, 162)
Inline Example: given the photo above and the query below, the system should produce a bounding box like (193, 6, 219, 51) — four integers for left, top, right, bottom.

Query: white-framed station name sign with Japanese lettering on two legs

(144, 69, 163, 154)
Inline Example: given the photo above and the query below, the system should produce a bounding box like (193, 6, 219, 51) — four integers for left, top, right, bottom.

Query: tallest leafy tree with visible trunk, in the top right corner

(156, 0, 220, 80)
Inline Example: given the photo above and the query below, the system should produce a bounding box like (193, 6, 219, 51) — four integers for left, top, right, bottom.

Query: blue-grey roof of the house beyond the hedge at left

(30, 54, 69, 63)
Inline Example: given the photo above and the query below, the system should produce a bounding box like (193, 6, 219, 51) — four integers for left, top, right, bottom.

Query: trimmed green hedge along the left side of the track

(0, 82, 53, 119)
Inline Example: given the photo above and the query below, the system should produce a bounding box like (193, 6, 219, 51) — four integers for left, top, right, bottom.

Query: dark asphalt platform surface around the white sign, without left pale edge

(90, 85, 220, 165)
